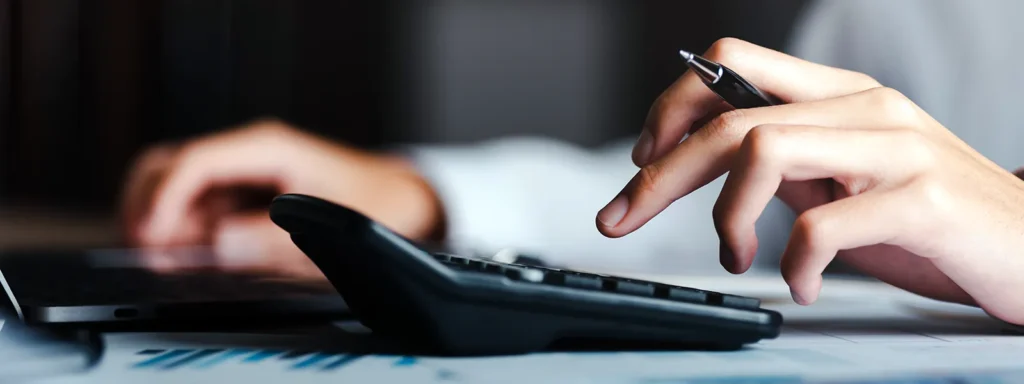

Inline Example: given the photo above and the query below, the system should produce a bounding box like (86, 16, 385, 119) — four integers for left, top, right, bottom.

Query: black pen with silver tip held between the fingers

(679, 50, 781, 110)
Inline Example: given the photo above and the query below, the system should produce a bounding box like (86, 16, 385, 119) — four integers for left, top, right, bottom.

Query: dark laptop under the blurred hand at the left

(0, 248, 349, 329)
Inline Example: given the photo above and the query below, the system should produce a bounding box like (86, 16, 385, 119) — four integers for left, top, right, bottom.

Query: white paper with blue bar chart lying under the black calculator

(28, 281, 1024, 384)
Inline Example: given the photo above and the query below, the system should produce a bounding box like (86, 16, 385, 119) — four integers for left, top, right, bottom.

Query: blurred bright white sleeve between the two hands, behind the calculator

(403, 137, 786, 273)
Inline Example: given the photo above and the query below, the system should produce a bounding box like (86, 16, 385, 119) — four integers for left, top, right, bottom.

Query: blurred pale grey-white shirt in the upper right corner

(792, 0, 1024, 173)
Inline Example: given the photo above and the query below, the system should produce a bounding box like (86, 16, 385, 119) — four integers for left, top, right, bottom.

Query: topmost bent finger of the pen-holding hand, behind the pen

(633, 38, 880, 167)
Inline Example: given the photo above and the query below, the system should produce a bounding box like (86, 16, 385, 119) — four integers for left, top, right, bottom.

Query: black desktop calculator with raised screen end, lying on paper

(270, 195, 782, 355)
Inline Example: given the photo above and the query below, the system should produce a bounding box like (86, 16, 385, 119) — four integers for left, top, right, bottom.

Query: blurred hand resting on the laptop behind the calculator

(122, 121, 443, 278)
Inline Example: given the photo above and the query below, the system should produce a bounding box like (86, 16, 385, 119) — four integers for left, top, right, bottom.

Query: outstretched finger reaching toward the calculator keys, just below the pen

(597, 88, 920, 237)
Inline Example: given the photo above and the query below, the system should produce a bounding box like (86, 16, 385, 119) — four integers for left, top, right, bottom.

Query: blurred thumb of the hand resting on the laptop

(213, 211, 325, 280)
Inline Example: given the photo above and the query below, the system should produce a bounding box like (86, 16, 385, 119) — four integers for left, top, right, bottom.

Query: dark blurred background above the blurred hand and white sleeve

(0, 0, 804, 210)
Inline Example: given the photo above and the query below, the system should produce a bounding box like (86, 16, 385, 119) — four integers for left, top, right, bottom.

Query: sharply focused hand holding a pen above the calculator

(597, 39, 1024, 324)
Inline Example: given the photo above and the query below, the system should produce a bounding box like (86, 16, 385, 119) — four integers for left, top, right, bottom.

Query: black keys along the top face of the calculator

(433, 253, 761, 309)
